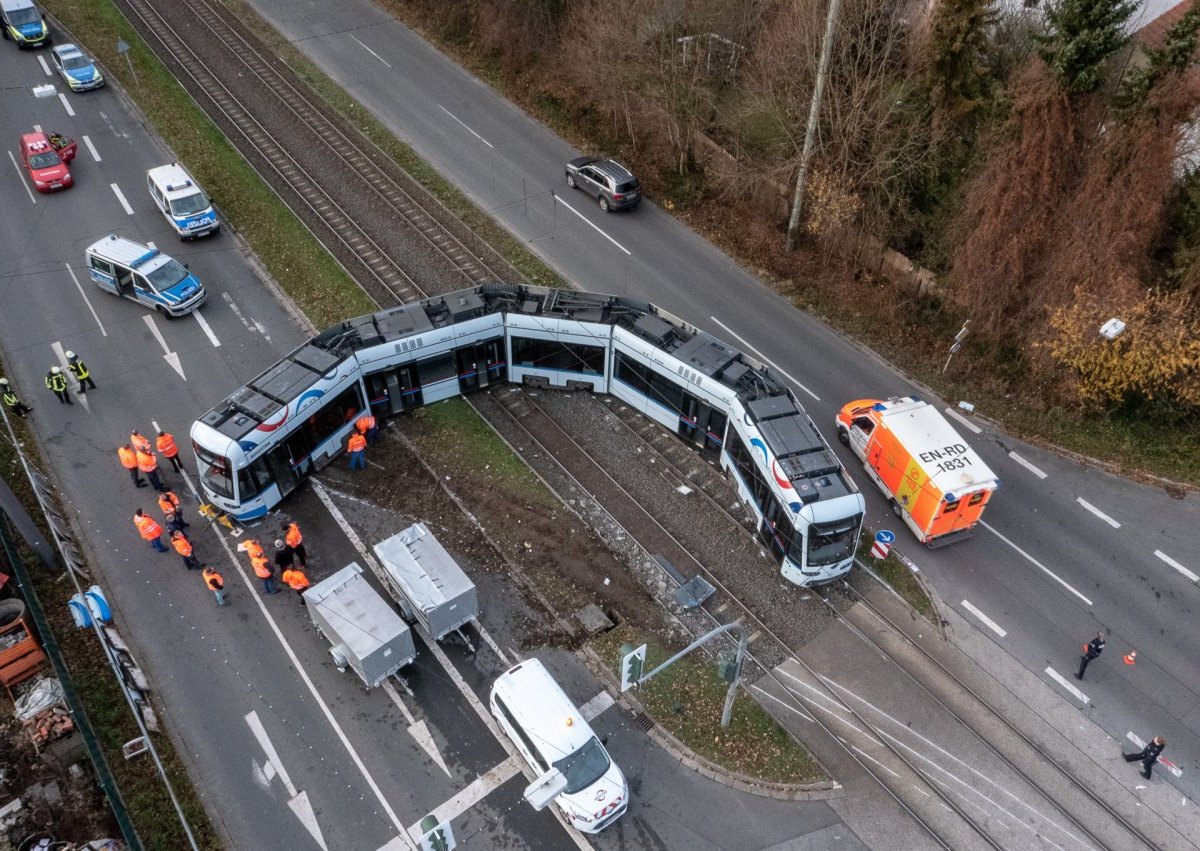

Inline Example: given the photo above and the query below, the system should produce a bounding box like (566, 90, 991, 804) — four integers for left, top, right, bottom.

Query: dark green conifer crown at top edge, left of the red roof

(1038, 0, 1138, 95)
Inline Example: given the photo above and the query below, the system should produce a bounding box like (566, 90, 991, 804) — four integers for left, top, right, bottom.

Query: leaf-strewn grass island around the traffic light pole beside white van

(589, 624, 828, 784)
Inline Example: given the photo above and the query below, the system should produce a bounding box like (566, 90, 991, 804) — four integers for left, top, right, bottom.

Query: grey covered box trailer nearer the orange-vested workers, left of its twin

(304, 562, 416, 689)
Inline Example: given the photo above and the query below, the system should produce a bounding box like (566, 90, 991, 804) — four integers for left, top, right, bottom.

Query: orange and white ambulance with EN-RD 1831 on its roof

(838, 396, 1000, 547)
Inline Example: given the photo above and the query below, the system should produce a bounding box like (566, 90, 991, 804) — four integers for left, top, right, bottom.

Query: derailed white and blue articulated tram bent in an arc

(191, 284, 865, 586)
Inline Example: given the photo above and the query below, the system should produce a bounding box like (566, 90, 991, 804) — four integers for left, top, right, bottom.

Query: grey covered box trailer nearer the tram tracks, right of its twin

(374, 523, 479, 651)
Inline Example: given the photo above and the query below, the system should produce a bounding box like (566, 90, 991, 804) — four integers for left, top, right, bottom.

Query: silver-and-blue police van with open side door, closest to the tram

(86, 234, 208, 319)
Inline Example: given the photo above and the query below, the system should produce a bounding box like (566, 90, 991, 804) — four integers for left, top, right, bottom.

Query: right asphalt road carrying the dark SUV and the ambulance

(251, 0, 1200, 797)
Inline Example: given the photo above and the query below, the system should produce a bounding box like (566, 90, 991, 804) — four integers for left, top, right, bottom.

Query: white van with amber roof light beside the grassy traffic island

(490, 659, 629, 833)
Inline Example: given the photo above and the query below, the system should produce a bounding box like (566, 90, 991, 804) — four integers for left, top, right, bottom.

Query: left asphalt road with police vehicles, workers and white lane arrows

(0, 26, 846, 851)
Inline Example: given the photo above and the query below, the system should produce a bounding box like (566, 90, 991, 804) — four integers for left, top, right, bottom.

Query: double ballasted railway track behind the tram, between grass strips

(114, 0, 518, 306)
